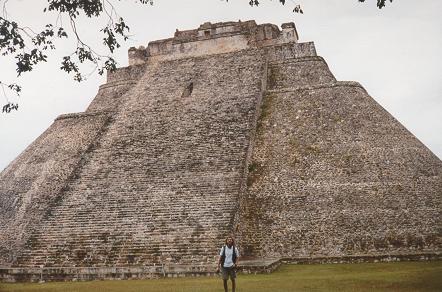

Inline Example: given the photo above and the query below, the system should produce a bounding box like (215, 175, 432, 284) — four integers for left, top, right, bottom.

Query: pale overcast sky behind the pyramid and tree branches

(0, 0, 442, 170)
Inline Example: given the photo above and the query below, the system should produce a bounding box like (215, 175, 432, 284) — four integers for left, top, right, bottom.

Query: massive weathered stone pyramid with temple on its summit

(0, 21, 442, 281)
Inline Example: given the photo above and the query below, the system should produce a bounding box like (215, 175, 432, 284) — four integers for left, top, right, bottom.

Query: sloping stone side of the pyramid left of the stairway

(0, 114, 109, 265)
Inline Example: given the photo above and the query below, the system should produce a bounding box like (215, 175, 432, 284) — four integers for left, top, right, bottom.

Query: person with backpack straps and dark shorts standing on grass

(217, 236, 239, 292)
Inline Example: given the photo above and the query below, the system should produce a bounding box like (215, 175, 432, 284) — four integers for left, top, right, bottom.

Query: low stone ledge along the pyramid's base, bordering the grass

(0, 252, 442, 283)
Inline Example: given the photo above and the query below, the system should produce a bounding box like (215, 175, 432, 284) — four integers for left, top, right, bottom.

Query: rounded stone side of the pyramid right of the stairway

(239, 72, 442, 258)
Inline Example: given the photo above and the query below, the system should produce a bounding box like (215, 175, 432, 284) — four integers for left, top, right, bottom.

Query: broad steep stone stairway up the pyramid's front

(13, 50, 264, 266)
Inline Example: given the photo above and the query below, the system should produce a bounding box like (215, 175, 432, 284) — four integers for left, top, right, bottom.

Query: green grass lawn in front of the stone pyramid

(0, 261, 442, 292)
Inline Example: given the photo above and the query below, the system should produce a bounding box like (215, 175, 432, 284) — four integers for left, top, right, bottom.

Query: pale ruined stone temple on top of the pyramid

(129, 20, 298, 65)
